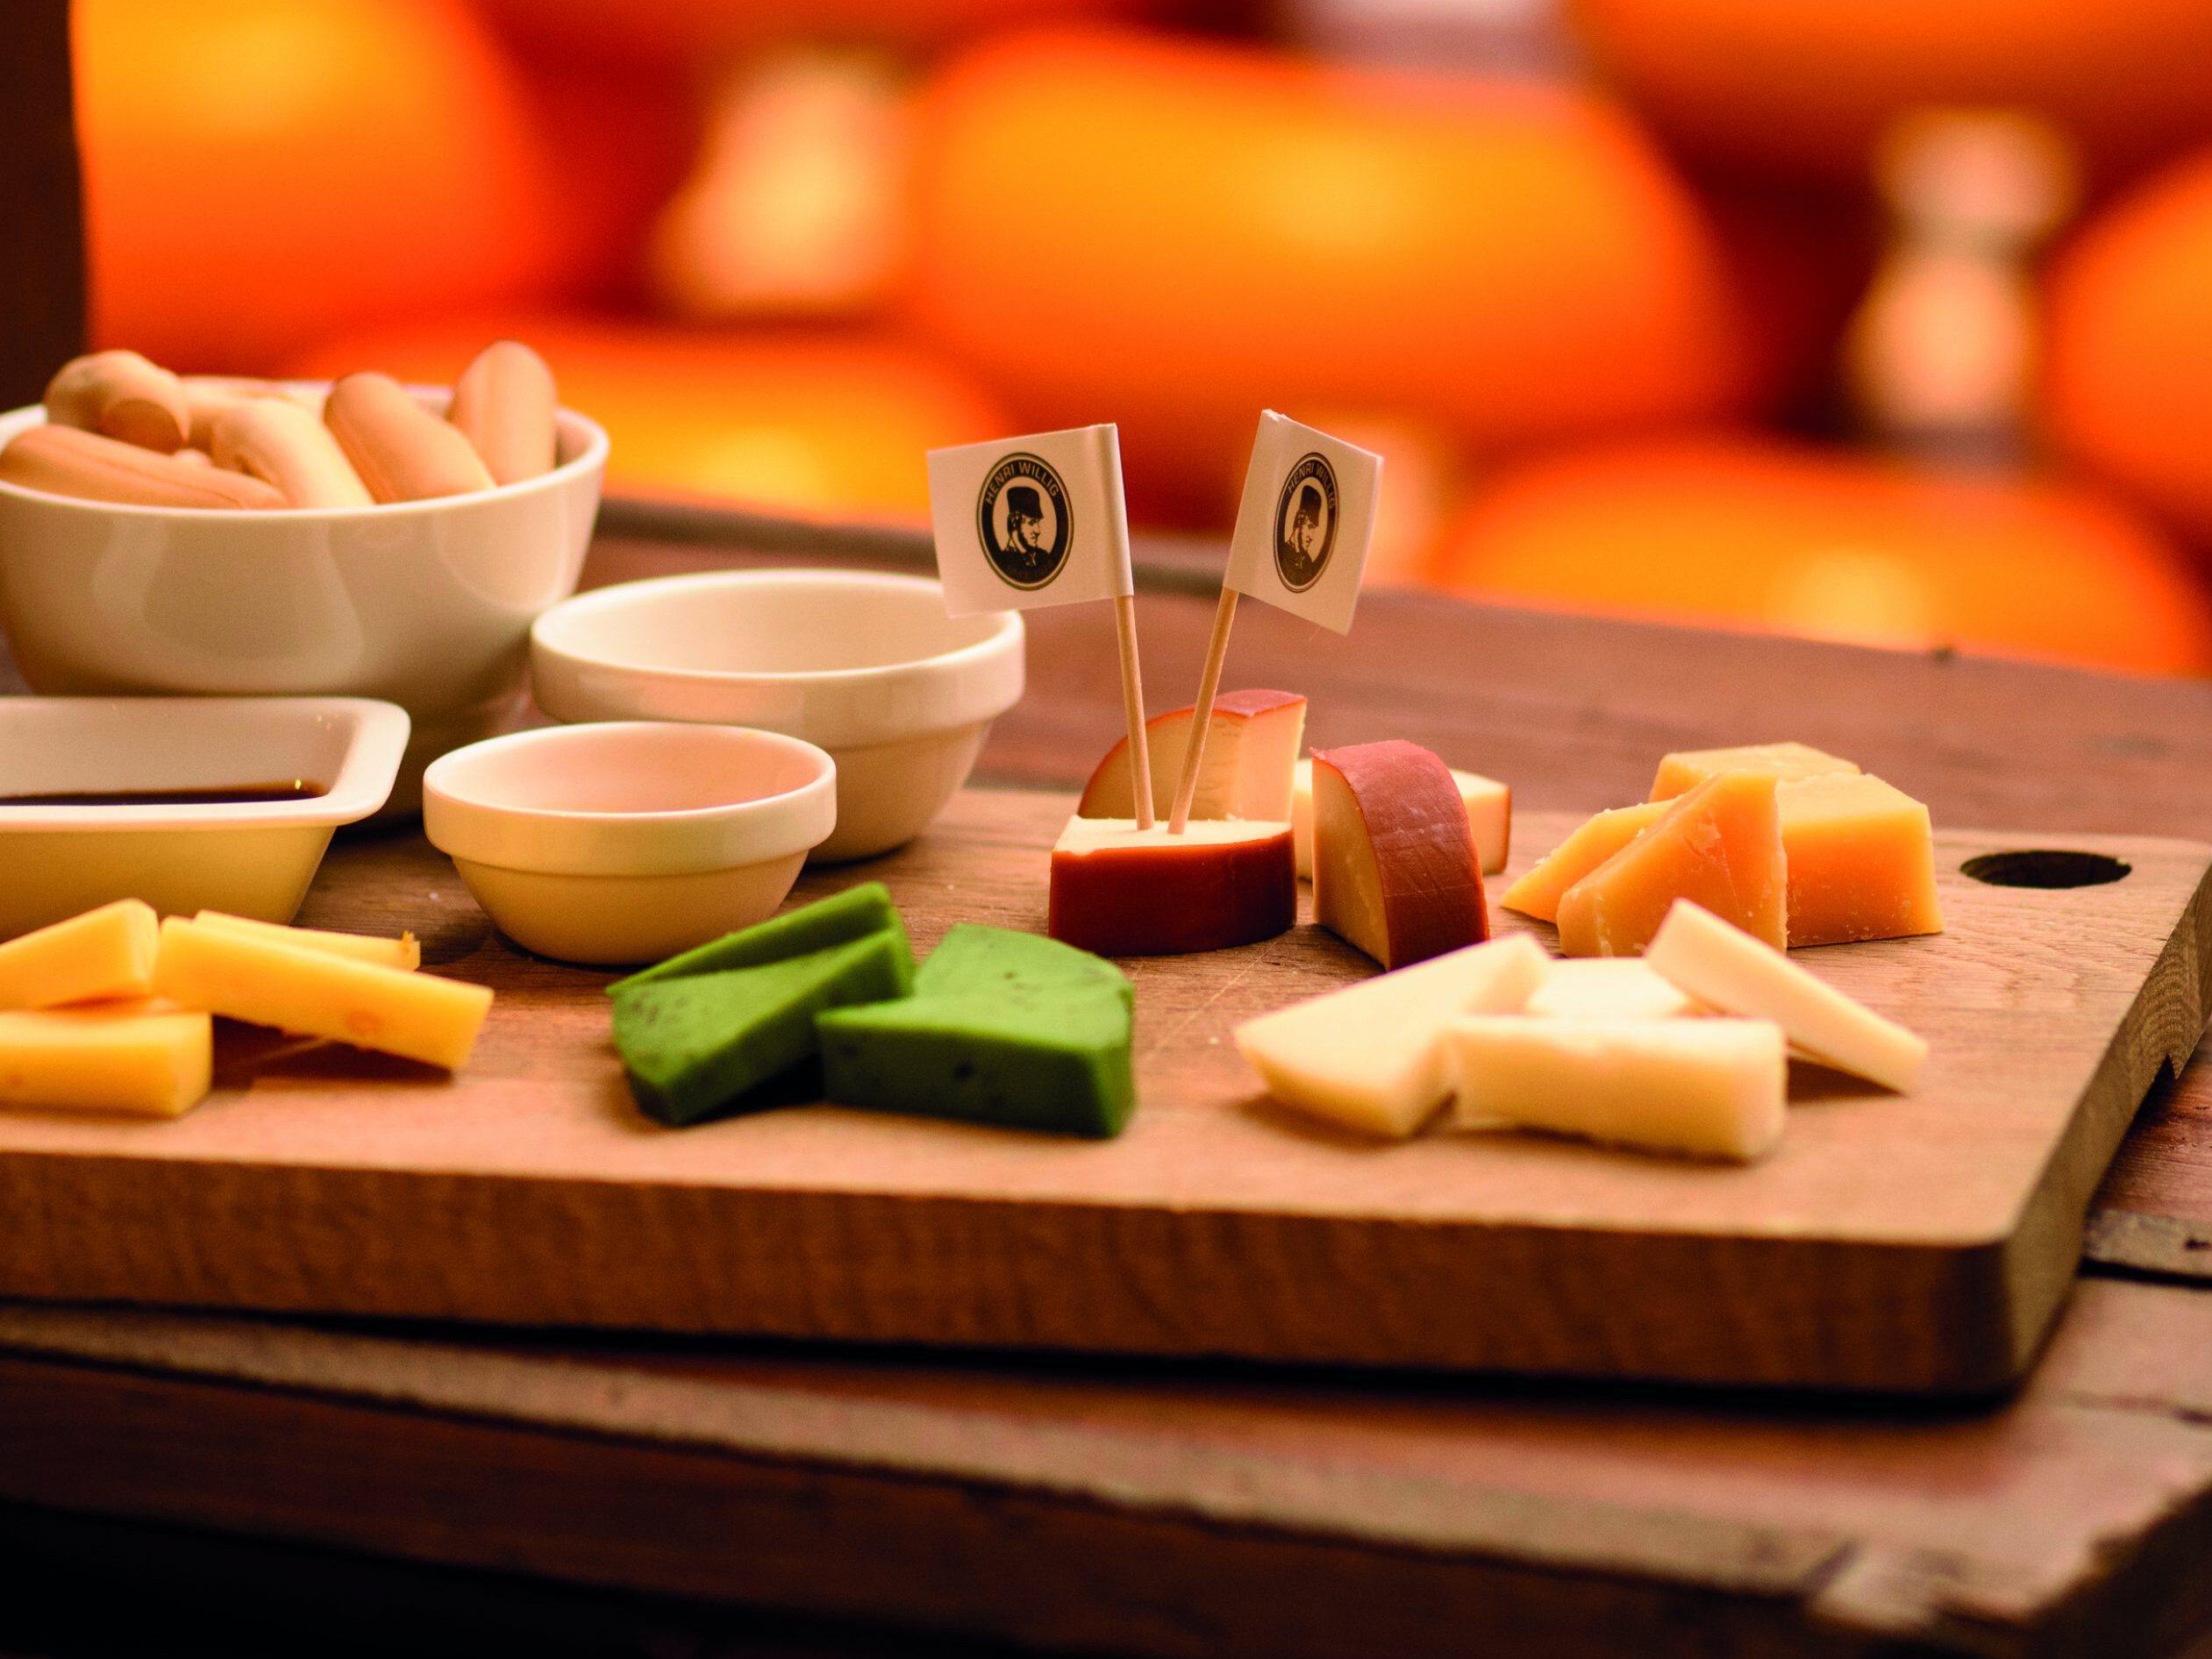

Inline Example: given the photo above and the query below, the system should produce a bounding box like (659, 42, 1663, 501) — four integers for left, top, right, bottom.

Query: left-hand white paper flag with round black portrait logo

(929, 427, 1137, 617)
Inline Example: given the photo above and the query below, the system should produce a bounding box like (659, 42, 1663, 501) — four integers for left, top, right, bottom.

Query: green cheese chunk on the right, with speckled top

(814, 927, 1137, 1139)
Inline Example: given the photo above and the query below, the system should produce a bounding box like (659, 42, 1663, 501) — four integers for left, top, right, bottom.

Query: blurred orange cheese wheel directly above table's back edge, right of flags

(1433, 436, 2212, 673)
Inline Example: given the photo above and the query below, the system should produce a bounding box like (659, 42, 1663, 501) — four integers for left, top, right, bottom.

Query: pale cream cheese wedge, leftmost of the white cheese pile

(1234, 934, 1548, 1137)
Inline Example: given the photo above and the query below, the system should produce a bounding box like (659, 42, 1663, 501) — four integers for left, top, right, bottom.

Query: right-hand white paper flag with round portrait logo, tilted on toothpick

(1224, 409, 1382, 632)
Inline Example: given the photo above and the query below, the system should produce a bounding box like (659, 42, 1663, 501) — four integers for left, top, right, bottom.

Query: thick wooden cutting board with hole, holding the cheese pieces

(0, 792, 2212, 1392)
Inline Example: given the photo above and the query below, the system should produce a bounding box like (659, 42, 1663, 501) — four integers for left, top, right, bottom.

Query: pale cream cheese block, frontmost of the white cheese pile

(1445, 1013, 1789, 1161)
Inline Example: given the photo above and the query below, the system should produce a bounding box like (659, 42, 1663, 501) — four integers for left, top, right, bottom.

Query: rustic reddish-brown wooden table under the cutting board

(0, 511, 2212, 1659)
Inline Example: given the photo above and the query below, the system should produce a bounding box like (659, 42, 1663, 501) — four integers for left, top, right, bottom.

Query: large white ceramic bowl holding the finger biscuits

(0, 387, 606, 812)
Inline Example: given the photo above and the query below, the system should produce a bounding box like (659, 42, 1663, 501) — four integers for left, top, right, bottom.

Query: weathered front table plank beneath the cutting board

(0, 1283, 2212, 1655)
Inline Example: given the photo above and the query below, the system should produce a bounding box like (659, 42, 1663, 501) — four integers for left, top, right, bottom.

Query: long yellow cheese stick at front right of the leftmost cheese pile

(155, 915, 491, 1071)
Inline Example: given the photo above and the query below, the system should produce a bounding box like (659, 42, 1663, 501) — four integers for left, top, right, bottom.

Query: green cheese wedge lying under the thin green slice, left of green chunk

(615, 931, 914, 1129)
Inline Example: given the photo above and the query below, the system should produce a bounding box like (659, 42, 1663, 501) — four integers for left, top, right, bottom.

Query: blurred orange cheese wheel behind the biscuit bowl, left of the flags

(292, 317, 1013, 522)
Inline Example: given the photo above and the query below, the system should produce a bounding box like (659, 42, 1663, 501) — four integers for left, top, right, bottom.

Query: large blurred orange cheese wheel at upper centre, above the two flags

(907, 29, 1752, 504)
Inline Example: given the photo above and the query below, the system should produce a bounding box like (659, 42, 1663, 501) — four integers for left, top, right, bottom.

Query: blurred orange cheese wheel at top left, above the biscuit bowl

(75, 0, 560, 372)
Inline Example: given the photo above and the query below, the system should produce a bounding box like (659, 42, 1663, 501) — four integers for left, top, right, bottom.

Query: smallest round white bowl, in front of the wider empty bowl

(423, 721, 836, 966)
